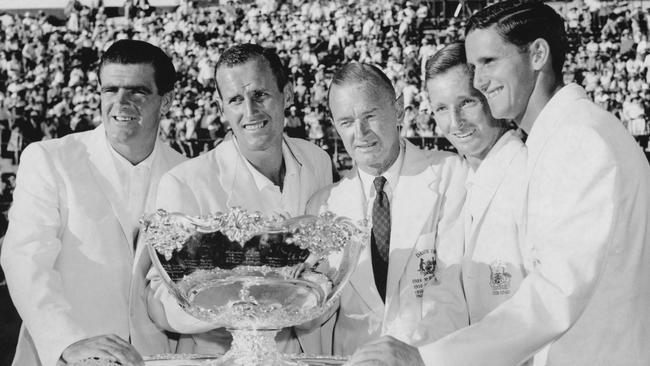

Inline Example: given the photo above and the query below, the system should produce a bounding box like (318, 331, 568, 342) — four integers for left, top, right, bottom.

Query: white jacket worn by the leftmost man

(2, 126, 183, 366)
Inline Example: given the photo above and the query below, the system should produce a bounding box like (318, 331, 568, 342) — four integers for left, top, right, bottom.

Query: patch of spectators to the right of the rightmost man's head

(564, 2, 650, 147)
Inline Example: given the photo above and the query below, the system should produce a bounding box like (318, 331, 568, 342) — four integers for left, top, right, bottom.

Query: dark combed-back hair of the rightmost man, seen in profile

(465, 0, 568, 77)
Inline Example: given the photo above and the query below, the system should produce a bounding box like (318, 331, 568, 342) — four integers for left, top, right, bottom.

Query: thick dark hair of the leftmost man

(99, 39, 176, 95)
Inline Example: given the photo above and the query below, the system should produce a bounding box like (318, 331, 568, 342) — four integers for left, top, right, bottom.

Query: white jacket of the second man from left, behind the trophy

(148, 137, 332, 353)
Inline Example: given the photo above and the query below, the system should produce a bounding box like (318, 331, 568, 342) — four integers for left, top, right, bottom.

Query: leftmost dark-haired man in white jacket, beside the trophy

(2, 40, 183, 366)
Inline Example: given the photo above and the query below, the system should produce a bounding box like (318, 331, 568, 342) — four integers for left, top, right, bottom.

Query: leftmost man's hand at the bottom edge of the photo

(61, 334, 144, 366)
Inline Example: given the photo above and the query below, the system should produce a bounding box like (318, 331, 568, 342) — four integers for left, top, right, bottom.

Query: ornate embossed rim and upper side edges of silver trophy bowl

(141, 207, 369, 316)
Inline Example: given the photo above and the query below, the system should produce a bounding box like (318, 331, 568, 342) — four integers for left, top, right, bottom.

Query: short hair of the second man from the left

(214, 43, 289, 95)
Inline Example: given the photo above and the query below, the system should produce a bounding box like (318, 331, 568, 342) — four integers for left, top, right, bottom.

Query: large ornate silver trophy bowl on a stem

(140, 207, 368, 366)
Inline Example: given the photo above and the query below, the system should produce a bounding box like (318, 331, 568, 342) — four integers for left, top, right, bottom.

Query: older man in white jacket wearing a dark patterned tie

(308, 63, 468, 355)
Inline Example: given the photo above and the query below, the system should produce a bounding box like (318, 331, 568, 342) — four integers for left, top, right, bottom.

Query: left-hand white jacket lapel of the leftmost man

(87, 125, 133, 254)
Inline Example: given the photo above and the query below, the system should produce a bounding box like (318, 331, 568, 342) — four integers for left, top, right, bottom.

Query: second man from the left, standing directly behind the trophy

(144, 44, 332, 354)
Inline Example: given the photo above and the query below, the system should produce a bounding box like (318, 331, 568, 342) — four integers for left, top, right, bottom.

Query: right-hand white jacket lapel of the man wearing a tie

(386, 143, 439, 303)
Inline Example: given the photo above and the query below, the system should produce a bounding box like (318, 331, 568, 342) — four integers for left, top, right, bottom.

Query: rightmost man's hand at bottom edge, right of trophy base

(345, 336, 424, 366)
